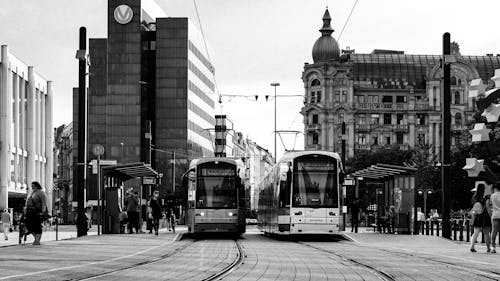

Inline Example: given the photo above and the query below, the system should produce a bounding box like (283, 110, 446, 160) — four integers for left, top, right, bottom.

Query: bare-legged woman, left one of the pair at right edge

(470, 184, 491, 253)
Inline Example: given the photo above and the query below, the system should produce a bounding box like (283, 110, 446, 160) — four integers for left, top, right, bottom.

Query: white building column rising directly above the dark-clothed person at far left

(26, 66, 36, 191)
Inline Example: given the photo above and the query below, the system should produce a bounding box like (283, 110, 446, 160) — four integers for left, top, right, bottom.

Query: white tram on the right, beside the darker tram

(258, 151, 343, 235)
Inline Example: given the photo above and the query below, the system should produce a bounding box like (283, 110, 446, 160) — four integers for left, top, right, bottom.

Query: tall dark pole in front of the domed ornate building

(441, 32, 451, 239)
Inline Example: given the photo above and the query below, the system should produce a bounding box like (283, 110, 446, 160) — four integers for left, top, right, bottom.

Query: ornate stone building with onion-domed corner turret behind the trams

(301, 9, 500, 160)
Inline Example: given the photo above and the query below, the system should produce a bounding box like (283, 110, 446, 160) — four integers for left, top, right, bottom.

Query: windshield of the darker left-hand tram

(196, 164, 238, 209)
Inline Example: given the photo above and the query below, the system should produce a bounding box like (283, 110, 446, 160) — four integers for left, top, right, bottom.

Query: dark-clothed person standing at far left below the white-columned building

(26, 181, 48, 245)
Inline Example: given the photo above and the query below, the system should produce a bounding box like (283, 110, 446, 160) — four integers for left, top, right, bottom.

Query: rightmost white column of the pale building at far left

(44, 81, 54, 211)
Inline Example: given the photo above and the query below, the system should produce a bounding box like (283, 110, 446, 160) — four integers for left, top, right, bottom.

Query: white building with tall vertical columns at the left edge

(0, 45, 53, 211)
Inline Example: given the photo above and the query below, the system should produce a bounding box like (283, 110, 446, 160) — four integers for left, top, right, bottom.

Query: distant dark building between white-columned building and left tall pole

(52, 123, 76, 223)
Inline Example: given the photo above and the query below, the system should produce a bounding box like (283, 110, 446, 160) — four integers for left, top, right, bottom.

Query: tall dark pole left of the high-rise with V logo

(76, 26, 87, 237)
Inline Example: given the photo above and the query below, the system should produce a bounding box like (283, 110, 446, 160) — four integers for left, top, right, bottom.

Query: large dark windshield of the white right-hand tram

(292, 156, 338, 208)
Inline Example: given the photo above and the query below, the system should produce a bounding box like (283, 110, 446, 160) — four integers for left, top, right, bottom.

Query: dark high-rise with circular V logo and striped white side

(73, 0, 215, 203)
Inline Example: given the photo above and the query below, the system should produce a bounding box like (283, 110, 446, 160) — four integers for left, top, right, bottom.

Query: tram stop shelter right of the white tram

(350, 163, 418, 234)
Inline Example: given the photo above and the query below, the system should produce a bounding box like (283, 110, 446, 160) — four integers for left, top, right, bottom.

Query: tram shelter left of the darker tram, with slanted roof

(100, 162, 159, 234)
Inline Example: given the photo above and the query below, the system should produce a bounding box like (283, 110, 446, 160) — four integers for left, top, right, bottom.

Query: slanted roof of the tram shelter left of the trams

(102, 162, 158, 181)
